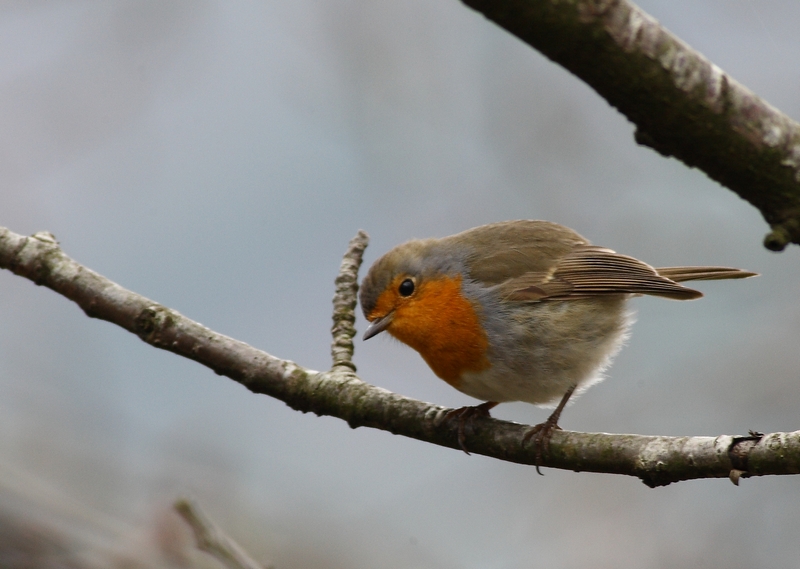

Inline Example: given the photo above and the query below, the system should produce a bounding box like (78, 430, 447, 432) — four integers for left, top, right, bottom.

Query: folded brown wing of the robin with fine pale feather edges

(499, 245, 703, 301)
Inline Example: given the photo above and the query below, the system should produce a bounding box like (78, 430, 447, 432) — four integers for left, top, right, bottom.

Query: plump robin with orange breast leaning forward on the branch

(359, 220, 756, 468)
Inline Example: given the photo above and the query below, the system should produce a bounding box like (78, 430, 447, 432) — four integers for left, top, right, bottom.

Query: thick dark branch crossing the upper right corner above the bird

(462, 0, 800, 251)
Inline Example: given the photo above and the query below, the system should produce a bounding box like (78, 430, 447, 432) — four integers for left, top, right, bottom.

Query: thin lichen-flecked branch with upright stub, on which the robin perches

(0, 227, 800, 487)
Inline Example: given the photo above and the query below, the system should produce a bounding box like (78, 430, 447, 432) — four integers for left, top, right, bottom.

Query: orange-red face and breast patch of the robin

(367, 275, 489, 387)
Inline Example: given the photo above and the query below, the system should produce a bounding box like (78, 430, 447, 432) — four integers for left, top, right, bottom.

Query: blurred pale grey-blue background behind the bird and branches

(0, 0, 800, 569)
